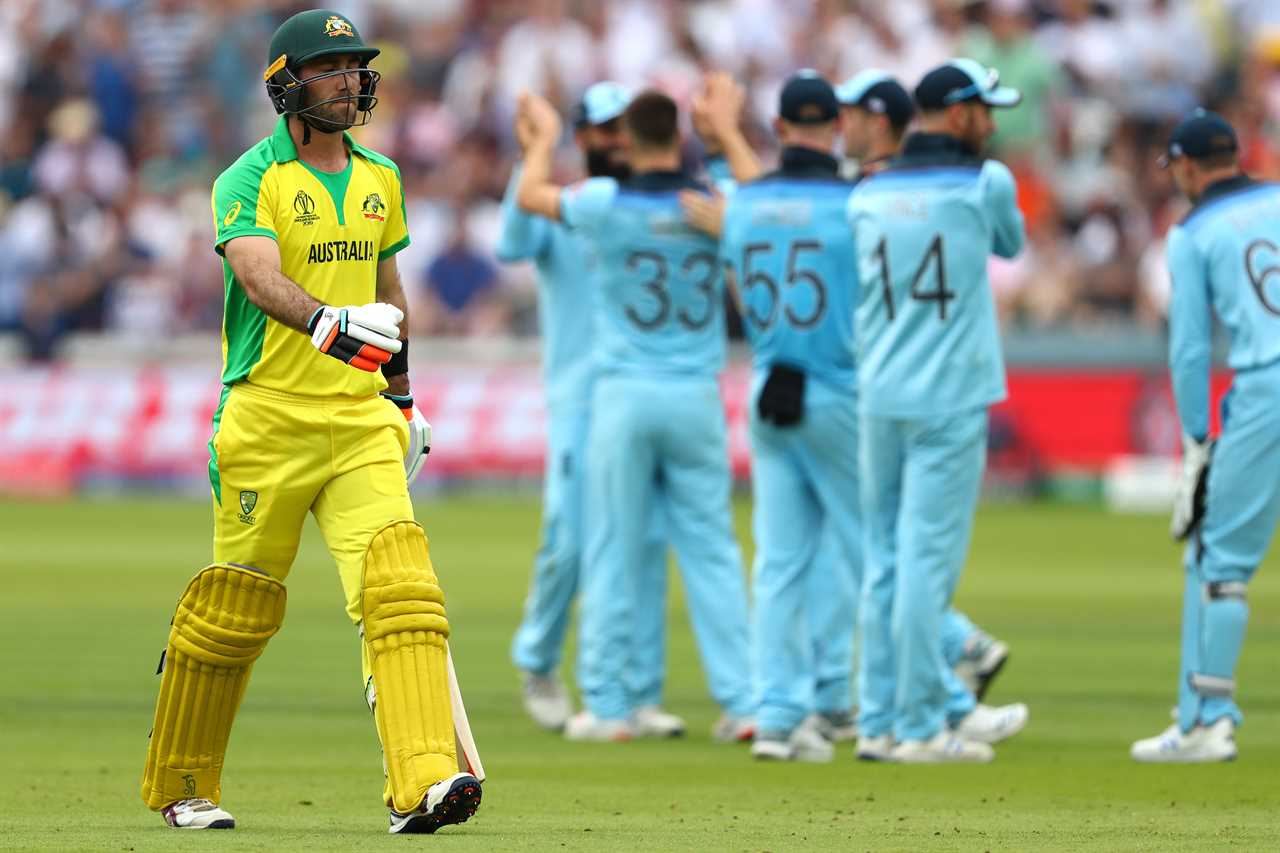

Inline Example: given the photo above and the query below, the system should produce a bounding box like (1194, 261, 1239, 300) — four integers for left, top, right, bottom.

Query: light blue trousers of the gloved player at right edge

(1178, 366, 1280, 731)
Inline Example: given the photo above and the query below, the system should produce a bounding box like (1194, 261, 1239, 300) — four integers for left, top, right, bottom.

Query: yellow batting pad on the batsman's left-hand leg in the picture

(142, 564, 284, 809)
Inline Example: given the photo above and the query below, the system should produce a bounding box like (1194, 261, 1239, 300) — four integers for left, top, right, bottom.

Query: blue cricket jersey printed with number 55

(721, 147, 858, 394)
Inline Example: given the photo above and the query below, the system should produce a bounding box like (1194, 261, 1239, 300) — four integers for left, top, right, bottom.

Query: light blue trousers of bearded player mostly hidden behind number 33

(511, 405, 667, 704)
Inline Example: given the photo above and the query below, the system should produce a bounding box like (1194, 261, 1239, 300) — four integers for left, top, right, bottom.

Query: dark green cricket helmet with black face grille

(262, 9, 381, 133)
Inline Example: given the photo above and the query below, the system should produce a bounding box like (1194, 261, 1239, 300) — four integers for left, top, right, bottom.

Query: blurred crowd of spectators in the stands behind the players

(0, 0, 1280, 359)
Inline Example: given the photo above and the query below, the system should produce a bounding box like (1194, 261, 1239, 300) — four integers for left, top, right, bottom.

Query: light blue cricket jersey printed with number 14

(847, 133, 1024, 418)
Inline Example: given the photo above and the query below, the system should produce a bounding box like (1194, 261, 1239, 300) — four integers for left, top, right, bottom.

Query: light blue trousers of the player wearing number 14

(858, 409, 987, 740)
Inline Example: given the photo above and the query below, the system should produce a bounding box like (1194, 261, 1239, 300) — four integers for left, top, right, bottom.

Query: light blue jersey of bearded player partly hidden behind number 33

(495, 165, 594, 407)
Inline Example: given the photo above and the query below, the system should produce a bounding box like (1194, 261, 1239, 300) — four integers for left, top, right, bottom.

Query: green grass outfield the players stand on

(0, 498, 1280, 850)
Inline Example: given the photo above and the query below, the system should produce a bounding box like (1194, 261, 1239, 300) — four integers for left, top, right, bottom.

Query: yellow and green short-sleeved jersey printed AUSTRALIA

(212, 115, 408, 397)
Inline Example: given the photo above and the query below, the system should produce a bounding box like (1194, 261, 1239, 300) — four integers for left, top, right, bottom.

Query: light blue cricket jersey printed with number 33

(561, 172, 724, 377)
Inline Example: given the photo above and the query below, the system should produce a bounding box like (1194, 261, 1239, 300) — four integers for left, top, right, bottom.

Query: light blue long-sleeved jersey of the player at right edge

(1166, 175, 1280, 439)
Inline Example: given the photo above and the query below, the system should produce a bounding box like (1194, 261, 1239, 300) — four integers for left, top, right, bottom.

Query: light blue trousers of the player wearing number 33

(577, 375, 755, 720)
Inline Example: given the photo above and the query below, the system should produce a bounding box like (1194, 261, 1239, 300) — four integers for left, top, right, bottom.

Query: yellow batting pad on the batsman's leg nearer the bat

(361, 521, 458, 812)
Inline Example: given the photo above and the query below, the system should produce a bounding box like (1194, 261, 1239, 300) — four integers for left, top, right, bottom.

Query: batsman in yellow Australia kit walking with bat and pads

(141, 9, 481, 833)
